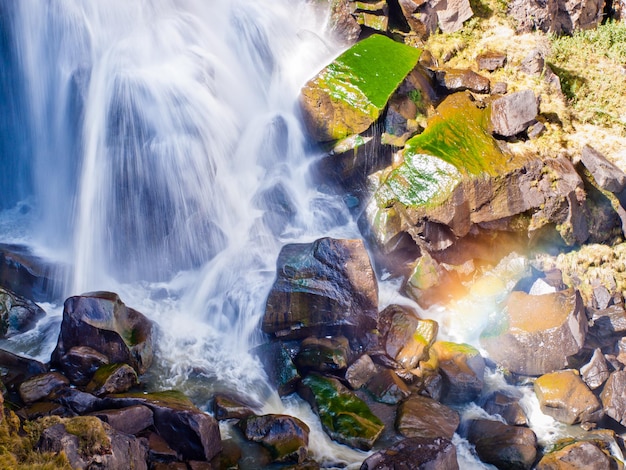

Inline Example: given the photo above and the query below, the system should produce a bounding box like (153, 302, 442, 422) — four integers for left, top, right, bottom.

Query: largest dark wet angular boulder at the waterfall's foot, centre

(262, 238, 378, 339)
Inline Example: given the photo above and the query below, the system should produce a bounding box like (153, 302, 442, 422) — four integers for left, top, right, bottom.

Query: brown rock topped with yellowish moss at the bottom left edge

(37, 416, 148, 470)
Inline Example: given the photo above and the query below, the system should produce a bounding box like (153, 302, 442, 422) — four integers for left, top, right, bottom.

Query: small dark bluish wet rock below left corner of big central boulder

(252, 341, 300, 397)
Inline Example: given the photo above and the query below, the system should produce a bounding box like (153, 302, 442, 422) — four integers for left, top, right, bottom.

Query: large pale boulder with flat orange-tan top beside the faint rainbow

(480, 288, 587, 375)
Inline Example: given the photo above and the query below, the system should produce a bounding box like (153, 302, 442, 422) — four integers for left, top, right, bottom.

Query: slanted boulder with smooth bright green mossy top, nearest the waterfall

(300, 35, 421, 142)
